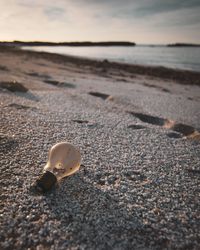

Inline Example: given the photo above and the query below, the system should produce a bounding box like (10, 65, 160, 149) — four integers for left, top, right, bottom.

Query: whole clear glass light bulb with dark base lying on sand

(36, 142, 81, 192)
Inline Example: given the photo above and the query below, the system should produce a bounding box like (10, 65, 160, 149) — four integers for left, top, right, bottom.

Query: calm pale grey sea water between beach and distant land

(23, 45, 200, 72)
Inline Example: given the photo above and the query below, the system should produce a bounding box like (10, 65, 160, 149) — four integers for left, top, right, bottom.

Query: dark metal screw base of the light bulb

(35, 171, 57, 193)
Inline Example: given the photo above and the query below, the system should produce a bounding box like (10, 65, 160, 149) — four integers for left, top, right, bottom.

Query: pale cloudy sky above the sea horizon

(0, 0, 200, 44)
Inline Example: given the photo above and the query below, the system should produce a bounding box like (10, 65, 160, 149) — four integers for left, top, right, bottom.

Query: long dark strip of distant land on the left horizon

(0, 41, 136, 46)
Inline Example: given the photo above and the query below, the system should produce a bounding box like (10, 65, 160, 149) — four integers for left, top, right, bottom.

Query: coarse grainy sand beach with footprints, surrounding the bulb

(0, 47, 200, 250)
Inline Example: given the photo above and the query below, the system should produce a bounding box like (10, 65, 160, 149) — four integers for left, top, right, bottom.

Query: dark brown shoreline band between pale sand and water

(0, 46, 200, 86)
